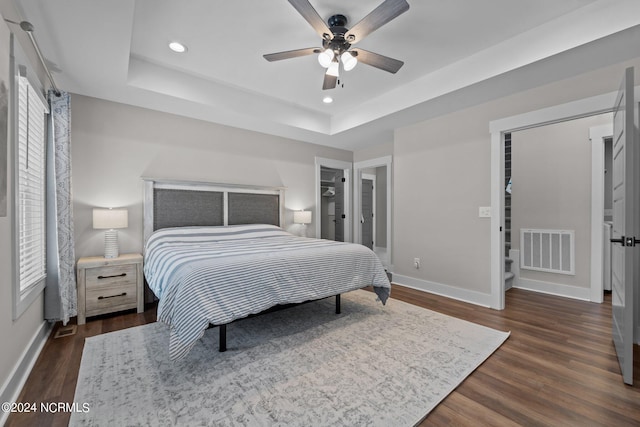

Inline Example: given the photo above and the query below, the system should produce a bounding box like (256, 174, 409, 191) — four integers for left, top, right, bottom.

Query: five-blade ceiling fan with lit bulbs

(263, 0, 409, 90)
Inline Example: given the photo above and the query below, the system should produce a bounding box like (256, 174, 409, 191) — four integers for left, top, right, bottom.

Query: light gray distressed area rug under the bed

(70, 291, 509, 426)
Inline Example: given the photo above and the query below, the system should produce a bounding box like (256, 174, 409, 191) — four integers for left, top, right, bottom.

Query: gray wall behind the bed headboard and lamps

(71, 95, 353, 257)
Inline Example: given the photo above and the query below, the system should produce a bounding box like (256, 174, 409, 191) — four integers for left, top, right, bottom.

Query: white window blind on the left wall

(17, 77, 47, 294)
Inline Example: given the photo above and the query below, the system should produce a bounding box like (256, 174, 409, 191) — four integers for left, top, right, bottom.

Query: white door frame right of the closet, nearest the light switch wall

(353, 156, 393, 270)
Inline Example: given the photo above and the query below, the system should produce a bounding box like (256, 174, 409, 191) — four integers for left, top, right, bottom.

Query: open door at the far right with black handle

(611, 68, 640, 384)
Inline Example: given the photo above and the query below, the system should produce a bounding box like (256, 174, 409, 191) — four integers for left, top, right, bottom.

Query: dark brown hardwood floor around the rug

(6, 285, 640, 426)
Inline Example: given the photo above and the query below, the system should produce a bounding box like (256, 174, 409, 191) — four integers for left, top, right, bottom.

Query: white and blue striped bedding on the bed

(144, 224, 391, 360)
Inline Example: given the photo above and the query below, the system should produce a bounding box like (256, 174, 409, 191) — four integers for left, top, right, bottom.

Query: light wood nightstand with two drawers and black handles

(77, 254, 144, 325)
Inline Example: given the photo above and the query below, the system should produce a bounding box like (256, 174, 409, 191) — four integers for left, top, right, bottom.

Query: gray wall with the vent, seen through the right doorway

(511, 114, 612, 288)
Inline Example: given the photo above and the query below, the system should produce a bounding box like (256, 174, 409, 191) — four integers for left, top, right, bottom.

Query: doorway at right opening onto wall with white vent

(504, 114, 612, 302)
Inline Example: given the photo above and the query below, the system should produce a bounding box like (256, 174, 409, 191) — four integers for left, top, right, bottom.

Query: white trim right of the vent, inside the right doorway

(589, 123, 613, 303)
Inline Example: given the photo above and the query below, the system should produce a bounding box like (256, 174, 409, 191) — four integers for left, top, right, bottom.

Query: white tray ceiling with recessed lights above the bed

(15, 0, 640, 149)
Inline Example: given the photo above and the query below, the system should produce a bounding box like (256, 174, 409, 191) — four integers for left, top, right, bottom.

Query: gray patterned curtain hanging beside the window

(44, 91, 78, 325)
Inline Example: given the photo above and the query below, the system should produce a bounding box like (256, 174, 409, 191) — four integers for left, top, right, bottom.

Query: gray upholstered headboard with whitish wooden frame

(143, 178, 284, 242)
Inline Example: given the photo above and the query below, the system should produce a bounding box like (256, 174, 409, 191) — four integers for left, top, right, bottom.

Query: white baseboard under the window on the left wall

(0, 321, 53, 425)
